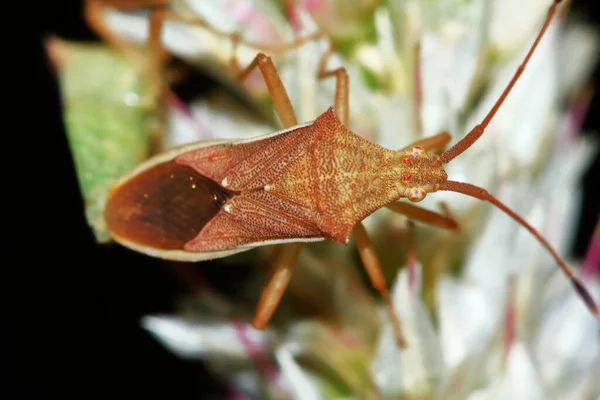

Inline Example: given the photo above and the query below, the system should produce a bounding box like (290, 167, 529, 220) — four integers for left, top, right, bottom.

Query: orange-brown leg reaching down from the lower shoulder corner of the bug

(353, 222, 406, 347)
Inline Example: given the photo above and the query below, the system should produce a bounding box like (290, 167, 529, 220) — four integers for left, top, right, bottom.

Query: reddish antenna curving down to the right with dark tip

(439, 181, 600, 318)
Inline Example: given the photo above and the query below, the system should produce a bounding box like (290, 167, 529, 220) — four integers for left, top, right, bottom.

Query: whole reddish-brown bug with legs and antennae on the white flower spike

(105, 0, 598, 345)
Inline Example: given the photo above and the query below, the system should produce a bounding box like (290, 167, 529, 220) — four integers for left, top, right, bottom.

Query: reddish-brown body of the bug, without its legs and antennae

(106, 108, 447, 258)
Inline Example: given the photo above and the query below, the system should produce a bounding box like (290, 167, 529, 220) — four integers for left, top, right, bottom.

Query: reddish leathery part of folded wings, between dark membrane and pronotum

(176, 126, 323, 251)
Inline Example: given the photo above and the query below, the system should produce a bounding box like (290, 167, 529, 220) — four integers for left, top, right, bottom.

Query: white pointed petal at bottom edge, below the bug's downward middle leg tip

(371, 264, 447, 396)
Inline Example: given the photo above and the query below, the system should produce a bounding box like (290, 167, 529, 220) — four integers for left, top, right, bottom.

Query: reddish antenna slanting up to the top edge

(440, 0, 562, 164)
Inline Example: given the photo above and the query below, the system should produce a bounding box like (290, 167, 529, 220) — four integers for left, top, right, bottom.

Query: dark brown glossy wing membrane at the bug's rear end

(104, 161, 232, 250)
